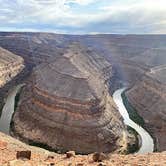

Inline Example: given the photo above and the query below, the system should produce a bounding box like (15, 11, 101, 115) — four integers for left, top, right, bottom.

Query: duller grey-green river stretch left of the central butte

(0, 84, 23, 135)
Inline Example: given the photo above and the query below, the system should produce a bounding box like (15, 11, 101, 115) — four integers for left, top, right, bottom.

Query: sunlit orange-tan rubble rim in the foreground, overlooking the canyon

(0, 133, 166, 166)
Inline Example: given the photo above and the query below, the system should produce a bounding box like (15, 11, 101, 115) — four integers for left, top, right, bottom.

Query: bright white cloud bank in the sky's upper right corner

(100, 0, 166, 33)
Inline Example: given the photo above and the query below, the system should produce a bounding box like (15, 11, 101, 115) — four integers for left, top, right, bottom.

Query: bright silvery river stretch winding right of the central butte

(113, 88, 154, 154)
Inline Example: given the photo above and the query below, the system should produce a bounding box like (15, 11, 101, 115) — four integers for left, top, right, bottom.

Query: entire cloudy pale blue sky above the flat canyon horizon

(0, 0, 166, 34)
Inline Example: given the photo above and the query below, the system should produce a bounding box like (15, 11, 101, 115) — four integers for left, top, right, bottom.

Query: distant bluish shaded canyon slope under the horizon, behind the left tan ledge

(0, 32, 72, 68)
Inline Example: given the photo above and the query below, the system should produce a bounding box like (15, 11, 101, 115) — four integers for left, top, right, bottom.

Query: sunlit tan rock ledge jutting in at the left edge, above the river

(0, 47, 24, 87)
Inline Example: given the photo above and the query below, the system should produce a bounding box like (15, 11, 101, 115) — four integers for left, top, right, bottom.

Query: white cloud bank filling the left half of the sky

(0, 0, 104, 27)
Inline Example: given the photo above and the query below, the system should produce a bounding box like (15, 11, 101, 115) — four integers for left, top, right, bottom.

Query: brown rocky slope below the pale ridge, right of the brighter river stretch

(127, 68, 166, 151)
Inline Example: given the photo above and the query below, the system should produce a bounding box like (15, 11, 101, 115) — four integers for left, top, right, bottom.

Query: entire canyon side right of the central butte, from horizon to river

(79, 35, 166, 151)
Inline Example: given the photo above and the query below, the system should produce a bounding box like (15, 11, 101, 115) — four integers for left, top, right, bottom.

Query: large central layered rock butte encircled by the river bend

(12, 43, 131, 153)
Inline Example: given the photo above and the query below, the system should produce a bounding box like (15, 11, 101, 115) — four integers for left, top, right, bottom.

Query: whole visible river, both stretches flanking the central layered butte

(0, 85, 154, 154)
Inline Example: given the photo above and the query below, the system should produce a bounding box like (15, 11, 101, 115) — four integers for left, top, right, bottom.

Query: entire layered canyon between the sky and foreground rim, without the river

(0, 32, 166, 165)
